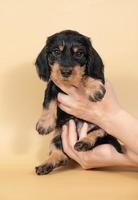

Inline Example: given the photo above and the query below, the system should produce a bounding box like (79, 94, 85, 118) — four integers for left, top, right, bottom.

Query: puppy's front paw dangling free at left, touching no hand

(36, 119, 55, 135)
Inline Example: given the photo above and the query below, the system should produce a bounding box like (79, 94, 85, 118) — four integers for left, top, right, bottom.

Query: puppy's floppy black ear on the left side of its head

(35, 46, 50, 81)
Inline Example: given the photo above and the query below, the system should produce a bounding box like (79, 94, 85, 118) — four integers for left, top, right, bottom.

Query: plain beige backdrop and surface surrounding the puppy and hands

(0, 0, 138, 200)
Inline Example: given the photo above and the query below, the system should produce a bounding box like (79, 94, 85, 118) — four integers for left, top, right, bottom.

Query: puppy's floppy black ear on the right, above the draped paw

(86, 41, 105, 83)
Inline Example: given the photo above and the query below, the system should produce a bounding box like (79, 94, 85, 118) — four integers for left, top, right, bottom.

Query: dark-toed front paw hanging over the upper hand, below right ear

(89, 85, 106, 102)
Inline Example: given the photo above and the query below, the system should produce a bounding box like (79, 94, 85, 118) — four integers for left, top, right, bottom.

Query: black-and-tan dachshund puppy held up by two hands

(36, 30, 121, 175)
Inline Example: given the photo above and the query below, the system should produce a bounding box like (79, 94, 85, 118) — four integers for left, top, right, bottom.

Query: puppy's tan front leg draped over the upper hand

(82, 76, 105, 102)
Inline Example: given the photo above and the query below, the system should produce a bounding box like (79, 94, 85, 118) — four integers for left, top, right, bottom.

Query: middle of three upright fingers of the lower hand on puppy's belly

(69, 120, 77, 146)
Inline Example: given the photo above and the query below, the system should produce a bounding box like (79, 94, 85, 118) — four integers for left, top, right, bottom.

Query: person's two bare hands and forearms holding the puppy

(53, 79, 138, 169)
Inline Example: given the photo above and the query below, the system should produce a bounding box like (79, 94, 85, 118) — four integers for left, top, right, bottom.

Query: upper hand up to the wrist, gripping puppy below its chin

(53, 80, 121, 126)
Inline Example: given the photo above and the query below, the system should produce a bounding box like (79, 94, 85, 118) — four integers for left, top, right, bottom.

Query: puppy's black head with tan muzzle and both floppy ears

(36, 30, 104, 82)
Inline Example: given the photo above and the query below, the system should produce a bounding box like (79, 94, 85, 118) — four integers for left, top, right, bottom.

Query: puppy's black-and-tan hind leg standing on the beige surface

(36, 129, 69, 175)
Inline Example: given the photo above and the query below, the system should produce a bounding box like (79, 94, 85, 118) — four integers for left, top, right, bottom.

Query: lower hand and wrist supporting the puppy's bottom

(62, 120, 138, 169)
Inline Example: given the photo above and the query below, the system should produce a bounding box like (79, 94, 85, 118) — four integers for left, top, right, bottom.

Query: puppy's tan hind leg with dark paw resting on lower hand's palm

(74, 128, 106, 151)
